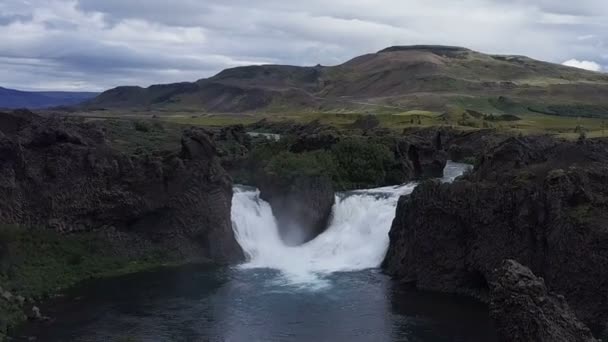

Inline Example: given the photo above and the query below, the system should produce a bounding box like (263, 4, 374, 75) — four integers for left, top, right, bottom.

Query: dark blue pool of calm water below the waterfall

(19, 266, 496, 342)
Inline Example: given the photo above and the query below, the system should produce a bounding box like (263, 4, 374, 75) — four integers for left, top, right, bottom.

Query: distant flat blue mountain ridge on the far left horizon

(0, 87, 99, 109)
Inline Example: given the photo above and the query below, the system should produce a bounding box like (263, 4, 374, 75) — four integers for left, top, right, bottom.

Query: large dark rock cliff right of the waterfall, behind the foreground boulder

(383, 137, 608, 329)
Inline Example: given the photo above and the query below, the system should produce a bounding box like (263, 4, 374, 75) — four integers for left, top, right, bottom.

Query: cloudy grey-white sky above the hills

(0, 0, 608, 90)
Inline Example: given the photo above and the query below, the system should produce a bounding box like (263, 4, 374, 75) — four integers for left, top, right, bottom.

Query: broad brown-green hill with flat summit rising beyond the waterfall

(86, 45, 608, 116)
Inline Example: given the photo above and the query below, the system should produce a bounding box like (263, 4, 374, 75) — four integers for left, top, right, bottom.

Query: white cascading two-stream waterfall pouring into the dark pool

(232, 162, 470, 286)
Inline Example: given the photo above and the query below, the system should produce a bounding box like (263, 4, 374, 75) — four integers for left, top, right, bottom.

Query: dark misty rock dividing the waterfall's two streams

(258, 175, 335, 245)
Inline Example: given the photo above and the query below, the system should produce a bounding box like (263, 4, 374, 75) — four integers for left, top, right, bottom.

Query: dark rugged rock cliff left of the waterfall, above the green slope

(0, 113, 242, 262)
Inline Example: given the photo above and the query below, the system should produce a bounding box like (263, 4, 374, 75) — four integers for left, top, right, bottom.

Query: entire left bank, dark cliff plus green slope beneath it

(0, 111, 243, 336)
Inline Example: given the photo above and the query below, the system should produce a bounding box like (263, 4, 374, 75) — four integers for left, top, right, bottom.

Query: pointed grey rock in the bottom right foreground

(490, 260, 597, 342)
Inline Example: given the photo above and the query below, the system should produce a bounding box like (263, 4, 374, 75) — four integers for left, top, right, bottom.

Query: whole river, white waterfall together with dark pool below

(19, 163, 496, 342)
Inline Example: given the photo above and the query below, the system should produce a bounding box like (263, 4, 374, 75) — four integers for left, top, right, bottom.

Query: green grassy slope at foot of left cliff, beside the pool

(0, 225, 204, 341)
